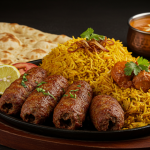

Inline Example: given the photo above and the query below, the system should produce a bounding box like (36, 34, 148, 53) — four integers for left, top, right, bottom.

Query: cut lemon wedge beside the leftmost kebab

(0, 65, 20, 95)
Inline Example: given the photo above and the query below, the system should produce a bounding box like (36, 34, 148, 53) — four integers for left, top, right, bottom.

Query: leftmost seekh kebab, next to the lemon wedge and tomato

(0, 67, 47, 115)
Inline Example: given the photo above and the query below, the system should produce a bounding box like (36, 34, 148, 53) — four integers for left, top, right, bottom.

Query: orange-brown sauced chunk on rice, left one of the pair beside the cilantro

(111, 61, 133, 88)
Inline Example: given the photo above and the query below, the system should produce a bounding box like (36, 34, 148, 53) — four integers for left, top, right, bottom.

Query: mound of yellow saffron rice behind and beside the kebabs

(41, 38, 150, 129)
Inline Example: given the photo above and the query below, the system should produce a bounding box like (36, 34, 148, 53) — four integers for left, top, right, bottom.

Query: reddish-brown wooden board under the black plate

(0, 119, 150, 150)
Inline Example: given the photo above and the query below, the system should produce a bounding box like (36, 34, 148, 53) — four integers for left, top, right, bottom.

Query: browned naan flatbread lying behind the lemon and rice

(0, 22, 71, 65)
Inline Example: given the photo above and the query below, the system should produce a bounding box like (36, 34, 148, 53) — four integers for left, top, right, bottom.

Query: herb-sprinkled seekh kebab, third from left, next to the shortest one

(53, 81, 93, 130)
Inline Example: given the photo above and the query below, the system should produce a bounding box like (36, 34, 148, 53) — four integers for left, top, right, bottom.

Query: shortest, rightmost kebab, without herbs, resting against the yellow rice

(90, 95, 124, 131)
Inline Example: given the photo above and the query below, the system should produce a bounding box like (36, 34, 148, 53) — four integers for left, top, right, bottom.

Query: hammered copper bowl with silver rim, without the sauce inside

(127, 12, 150, 57)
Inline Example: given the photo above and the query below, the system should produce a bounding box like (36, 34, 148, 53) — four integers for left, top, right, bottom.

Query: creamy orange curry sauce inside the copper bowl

(130, 16, 150, 32)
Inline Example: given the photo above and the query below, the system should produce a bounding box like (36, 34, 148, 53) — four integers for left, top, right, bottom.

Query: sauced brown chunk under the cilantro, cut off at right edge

(133, 70, 150, 92)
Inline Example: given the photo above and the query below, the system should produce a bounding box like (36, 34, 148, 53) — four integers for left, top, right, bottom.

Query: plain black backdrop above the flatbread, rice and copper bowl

(0, 0, 150, 150)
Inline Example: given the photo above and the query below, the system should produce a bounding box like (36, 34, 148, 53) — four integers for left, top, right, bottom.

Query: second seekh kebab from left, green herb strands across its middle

(20, 75, 68, 124)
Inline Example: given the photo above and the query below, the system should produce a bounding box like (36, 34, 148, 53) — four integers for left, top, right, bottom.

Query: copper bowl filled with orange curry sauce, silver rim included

(127, 12, 150, 57)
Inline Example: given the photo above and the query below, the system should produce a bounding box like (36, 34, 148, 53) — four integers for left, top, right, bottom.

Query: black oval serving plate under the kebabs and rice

(0, 59, 150, 141)
